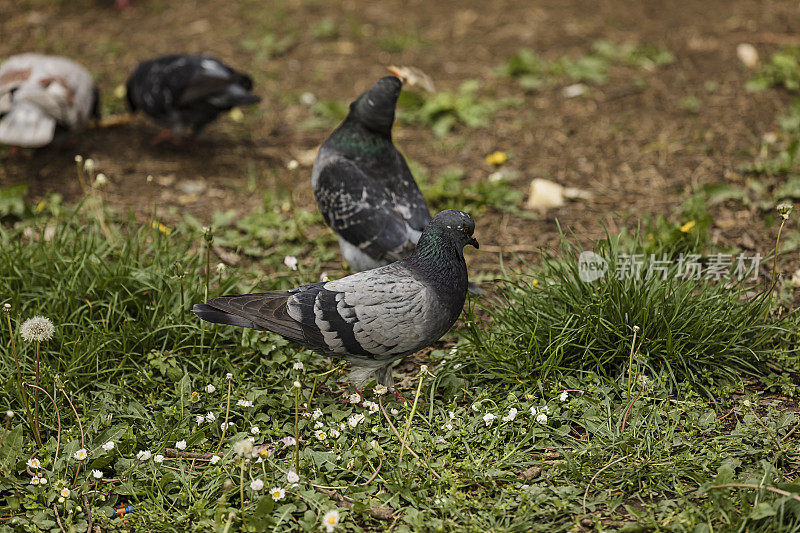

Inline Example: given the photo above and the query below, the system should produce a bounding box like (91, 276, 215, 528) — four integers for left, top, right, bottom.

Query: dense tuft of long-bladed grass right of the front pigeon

(466, 230, 795, 395)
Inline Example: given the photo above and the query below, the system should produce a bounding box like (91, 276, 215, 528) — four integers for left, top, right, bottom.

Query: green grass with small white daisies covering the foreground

(0, 185, 800, 531)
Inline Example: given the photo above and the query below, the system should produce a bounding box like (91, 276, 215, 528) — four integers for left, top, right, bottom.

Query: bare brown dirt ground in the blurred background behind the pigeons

(0, 0, 800, 275)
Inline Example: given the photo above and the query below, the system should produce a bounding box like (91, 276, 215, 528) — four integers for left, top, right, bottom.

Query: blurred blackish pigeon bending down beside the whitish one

(126, 54, 261, 138)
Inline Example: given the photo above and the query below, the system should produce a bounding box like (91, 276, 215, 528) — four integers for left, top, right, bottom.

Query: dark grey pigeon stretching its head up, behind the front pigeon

(311, 76, 431, 271)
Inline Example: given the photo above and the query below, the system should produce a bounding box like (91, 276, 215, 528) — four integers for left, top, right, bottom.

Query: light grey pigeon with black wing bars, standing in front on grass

(192, 209, 478, 390)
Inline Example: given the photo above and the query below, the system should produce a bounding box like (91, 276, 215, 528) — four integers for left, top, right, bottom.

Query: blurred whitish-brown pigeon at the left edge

(0, 53, 99, 148)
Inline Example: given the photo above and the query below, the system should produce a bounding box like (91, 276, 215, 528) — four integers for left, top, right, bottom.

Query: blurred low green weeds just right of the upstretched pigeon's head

(397, 80, 522, 137)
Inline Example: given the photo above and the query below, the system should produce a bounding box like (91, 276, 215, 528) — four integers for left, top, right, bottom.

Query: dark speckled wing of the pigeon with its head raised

(314, 158, 421, 260)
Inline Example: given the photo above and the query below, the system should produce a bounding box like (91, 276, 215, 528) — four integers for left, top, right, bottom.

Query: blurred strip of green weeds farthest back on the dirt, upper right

(496, 41, 674, 91)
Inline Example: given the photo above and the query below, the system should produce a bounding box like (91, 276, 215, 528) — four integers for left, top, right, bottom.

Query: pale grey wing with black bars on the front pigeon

(194, 263, 439, 359)
